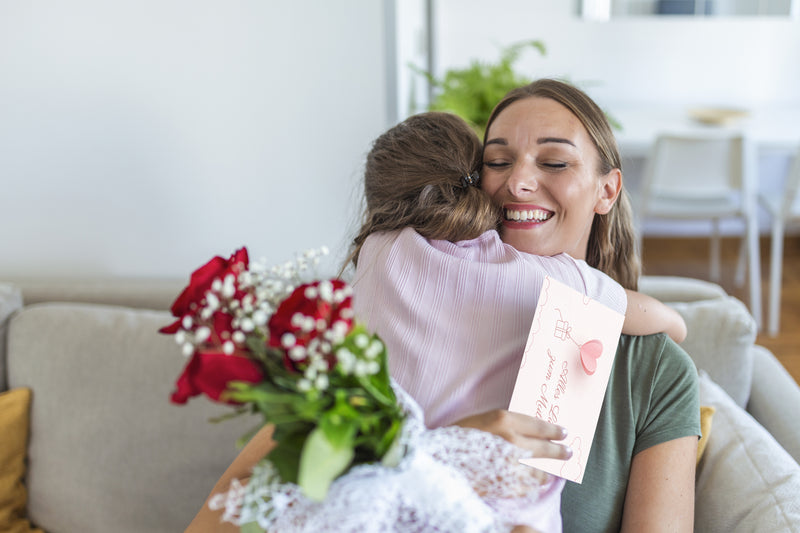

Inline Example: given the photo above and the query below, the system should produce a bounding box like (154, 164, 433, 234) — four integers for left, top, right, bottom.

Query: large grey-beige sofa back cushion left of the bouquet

(8, 304, 256, 533)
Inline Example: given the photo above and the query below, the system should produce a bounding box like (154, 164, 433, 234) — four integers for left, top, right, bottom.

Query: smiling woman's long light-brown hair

(484, 79, 641, 290)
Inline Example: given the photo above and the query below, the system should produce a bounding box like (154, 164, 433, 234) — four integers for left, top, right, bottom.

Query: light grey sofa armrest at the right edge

(747, 346, 800, 462)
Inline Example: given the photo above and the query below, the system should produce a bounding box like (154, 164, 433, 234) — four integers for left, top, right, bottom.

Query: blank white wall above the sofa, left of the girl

(0, 0, 389, 278)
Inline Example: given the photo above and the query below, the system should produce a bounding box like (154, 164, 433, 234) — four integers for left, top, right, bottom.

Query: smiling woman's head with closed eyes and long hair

(481, 79, 639, 289)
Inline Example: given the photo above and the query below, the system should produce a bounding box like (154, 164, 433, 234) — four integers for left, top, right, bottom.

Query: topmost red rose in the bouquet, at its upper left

(159, 247, 249, 334)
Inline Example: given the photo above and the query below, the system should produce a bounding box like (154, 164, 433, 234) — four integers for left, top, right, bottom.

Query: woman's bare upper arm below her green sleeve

(621, 436, 697, 533)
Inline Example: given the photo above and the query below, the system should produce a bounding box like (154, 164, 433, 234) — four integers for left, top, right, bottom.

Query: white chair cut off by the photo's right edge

(758, 145, 800, 337)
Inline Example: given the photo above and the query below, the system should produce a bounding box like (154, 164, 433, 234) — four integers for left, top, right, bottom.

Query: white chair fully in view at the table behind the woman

(635, 130, 761, 327)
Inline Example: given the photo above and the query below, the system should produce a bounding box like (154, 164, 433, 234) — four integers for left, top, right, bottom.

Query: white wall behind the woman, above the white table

(435, 0, 800, 106)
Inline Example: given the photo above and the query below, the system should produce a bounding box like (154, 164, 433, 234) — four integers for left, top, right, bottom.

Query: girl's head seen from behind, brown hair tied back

(351, 112, 499, 263)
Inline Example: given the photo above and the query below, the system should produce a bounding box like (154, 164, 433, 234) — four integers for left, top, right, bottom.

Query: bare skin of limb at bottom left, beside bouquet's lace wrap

(185, 425, 275, 533)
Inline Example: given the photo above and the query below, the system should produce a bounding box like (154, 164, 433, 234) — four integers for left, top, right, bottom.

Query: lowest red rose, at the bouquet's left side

(171, 351, 263, 405)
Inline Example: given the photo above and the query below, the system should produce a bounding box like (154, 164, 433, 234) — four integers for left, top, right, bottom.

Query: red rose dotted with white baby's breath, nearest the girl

(268, 279, 353, 368)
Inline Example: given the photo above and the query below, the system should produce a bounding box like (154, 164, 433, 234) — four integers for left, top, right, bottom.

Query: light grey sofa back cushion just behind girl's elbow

(670, 296, 757, 407)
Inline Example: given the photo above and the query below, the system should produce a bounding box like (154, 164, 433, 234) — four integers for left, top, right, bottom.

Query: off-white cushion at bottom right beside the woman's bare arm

(695, 371, 800, 533)
